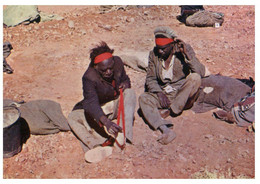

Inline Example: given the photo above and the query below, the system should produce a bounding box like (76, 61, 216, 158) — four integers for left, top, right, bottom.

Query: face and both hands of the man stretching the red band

(94, 57, 130, 138)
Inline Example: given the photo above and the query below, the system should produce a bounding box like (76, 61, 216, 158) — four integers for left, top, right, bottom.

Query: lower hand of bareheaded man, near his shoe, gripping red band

(100, 116, 122, 138)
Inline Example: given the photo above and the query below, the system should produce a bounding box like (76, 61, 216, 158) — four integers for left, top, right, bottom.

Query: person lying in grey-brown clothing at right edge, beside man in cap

(191, 75, 255, 131)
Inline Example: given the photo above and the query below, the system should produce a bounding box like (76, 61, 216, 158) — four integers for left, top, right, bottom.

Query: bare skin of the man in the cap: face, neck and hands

(156, 39, 190, 108)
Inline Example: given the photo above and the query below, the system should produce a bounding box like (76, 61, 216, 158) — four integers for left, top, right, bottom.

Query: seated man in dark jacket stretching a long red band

(68, 42, 136, 162)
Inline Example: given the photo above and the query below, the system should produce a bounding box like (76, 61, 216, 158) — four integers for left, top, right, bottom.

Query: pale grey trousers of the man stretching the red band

(68, 89, 136, 152)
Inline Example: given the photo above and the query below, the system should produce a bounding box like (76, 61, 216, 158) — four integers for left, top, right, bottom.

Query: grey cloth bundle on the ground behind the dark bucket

(3, 99, 70, 135)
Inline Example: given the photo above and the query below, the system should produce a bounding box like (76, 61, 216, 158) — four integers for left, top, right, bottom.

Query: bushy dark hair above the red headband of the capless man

(90, 41, 114, 66)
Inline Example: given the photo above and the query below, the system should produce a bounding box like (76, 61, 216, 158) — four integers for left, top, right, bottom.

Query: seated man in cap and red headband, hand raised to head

(139, 27, 205, 144)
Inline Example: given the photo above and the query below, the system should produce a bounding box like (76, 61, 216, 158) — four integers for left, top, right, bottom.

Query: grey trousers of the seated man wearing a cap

(139, 73, 201, 129)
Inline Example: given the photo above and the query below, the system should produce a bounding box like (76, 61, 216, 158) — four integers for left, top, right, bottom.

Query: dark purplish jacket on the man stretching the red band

(73, 56, 130, 122)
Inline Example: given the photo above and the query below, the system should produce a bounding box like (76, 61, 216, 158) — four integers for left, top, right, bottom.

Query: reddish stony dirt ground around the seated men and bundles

(3, 6, 255, 179)
